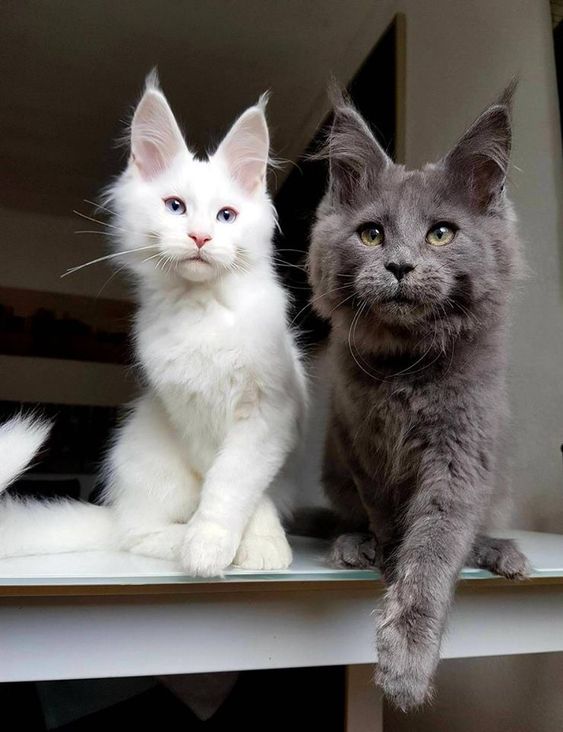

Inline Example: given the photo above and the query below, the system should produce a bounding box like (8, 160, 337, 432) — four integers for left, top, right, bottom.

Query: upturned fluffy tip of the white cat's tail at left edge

(0, 416, 51, 493)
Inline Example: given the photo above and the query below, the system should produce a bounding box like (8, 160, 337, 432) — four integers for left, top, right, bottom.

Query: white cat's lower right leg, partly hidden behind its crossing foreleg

(233, 496, 292, 569)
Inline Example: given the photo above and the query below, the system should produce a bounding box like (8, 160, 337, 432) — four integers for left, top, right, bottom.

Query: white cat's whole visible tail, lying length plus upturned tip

(0, 417, 115, 557)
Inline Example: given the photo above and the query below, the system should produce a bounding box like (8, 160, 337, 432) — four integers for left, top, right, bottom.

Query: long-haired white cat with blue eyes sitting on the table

(0, 75, 306, 576)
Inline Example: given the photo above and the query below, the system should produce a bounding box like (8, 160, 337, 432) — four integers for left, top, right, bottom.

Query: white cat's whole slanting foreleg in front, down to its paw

(181, 400, 295, 577)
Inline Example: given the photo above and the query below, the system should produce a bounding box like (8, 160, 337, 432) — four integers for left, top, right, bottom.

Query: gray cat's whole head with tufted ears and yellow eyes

(310, 89, 515, 331)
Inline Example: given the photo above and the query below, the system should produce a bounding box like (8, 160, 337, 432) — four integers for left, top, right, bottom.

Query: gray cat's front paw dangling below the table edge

(375, 602, 439, 712)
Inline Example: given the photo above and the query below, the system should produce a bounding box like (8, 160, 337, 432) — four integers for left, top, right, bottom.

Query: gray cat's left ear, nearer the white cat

(327, 87, 392, 204)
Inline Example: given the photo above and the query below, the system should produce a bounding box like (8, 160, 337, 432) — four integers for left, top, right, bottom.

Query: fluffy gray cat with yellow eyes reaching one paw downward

(309, 88, 528, 709)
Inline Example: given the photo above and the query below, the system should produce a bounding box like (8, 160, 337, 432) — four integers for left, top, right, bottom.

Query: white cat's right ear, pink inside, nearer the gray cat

(214, 95, 270, 194)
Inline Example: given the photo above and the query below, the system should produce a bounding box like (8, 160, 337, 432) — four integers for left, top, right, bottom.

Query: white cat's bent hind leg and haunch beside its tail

(107, 396, 201, 559)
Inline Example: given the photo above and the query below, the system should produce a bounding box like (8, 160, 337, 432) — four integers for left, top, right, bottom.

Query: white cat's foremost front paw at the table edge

(181, 520, 238, 577)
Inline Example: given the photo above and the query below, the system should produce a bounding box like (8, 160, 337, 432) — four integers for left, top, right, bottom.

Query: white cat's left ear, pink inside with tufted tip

(131, 71, 187, 180)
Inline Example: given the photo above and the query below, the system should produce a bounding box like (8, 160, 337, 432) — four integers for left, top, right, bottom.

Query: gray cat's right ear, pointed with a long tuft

(443, 82, 516, 211)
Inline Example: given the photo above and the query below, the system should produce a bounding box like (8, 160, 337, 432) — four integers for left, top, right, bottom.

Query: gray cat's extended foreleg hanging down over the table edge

(377, 431, 489, 710)
